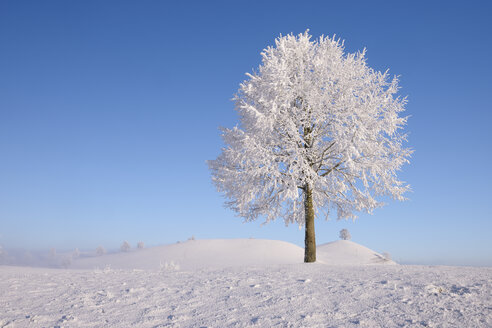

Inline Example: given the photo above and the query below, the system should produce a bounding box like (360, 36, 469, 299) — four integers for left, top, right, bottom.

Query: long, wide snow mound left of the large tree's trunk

(70, 239, 304, 270)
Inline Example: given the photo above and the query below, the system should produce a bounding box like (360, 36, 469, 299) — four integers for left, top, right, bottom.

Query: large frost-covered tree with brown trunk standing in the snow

(208, 31, 411, 262)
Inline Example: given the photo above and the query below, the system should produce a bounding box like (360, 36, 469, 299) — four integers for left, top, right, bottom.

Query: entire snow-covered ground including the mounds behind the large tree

(0, 240, 492, 327)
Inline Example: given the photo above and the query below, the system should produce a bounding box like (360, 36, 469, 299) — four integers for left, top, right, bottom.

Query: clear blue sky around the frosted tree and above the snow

(0, 0, 492, 265)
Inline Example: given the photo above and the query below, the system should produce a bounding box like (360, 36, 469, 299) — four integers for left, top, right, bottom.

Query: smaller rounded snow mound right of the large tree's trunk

(316, 240, 396, 265)
